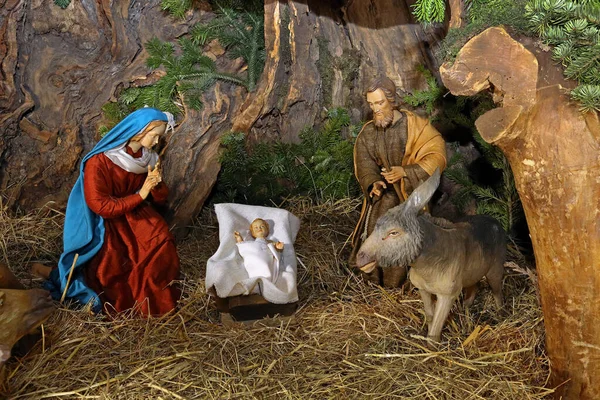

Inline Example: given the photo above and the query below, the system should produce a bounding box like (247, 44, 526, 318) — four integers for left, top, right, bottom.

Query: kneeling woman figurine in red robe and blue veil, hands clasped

(47, 108, 180, 315)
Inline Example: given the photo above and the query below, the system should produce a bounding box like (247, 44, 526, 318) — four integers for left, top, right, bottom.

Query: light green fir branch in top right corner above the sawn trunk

(525, 0, 600, 112)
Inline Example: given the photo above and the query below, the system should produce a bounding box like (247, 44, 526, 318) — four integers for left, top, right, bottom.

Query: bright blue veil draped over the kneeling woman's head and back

(44, 108, 168, 312)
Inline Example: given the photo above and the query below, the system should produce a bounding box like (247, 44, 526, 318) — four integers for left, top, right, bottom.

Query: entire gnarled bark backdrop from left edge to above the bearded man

(0, 0, 441, 231)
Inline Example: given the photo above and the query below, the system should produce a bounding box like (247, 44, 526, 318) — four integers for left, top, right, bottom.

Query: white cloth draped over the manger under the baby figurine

(206, 203, 300, 304)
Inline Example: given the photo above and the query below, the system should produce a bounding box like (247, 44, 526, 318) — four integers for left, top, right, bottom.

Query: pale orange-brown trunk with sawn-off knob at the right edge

(440, 28, 600, 399)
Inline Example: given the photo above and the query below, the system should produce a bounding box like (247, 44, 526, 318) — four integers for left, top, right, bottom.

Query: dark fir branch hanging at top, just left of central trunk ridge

(190, 0, 265, 90)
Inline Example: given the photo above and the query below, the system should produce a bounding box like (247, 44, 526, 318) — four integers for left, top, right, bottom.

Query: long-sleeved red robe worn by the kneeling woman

(84, 146, 180, 315)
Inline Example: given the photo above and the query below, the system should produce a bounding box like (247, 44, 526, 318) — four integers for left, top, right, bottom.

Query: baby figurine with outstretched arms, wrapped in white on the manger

(233, 218, 283, 283)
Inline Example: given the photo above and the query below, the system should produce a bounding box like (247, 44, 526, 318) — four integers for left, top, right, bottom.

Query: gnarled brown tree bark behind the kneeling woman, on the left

(0, 0, 245, 234)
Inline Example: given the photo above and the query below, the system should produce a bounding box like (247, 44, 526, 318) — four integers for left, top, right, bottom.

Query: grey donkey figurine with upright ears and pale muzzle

(357, 170, 506, 341)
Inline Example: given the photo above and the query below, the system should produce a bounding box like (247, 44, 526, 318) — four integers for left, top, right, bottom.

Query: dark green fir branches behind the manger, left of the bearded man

(214, 109, 359, 204)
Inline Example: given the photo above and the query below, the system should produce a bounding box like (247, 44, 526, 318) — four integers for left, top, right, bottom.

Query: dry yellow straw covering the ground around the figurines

(0, 199, 551, 399)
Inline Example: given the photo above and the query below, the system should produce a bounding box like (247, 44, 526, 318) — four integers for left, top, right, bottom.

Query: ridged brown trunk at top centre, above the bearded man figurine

(233, 0, 441, 141)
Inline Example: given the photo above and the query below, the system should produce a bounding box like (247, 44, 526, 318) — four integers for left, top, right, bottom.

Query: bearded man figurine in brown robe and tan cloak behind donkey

(350, 77, 446, 287)
